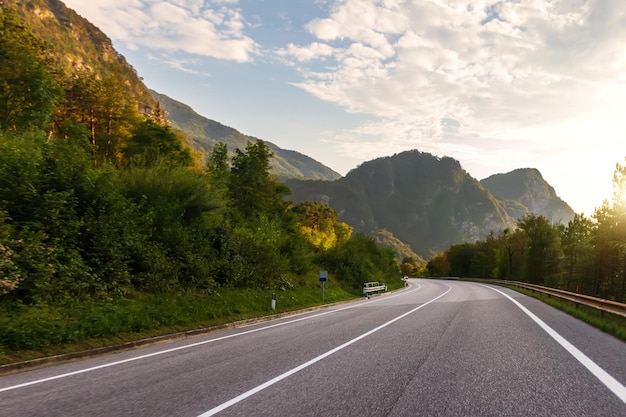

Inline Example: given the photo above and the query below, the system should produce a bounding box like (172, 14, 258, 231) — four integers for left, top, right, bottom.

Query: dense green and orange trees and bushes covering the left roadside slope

(0, 7, 399, 306)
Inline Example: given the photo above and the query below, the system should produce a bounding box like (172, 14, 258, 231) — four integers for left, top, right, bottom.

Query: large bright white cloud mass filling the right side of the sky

(276, 0, 626, 213)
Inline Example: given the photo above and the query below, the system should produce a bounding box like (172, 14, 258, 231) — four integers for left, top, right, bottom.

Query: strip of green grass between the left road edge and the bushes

(0, 283, 358, 365)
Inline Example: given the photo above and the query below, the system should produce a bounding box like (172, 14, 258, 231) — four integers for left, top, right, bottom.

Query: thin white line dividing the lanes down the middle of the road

(198, 284, 452, 417)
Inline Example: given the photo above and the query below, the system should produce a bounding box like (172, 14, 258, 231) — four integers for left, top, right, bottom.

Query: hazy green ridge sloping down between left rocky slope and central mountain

(150, 90, 341, 181)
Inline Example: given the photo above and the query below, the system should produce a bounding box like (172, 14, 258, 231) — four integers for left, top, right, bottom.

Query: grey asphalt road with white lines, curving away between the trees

(0, 279, 626, 417)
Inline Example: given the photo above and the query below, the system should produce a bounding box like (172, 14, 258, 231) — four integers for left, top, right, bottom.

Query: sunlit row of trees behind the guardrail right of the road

(428, 163, 626, 301)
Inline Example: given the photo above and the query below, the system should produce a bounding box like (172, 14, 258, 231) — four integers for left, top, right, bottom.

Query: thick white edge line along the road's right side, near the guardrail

(479, 284, 626, 403)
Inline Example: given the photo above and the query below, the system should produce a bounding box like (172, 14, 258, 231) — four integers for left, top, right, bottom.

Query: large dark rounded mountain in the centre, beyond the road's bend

(287, 150, 515, 258)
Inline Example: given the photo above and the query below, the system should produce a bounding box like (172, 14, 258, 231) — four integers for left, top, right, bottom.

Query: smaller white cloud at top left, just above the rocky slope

(65, 0, 258, 62)
